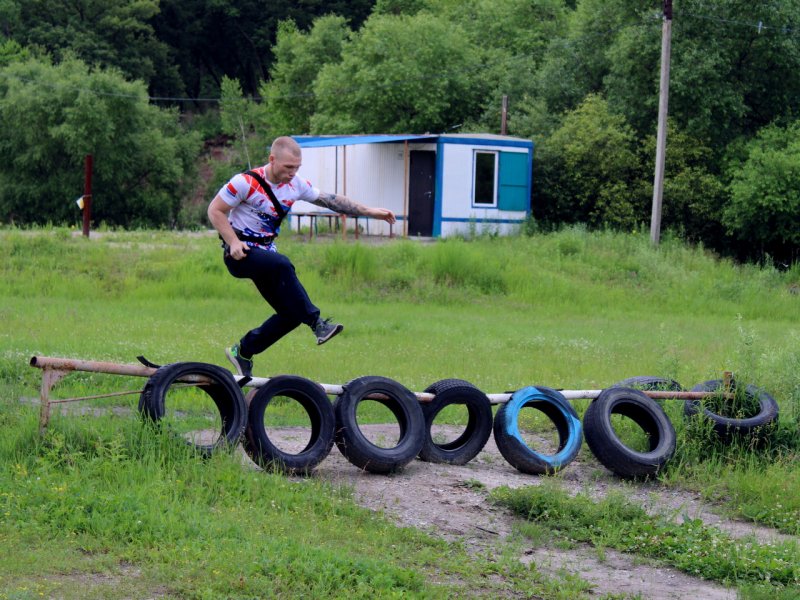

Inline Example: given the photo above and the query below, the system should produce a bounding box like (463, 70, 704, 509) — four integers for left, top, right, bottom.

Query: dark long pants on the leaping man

(225, 248, 319, 356)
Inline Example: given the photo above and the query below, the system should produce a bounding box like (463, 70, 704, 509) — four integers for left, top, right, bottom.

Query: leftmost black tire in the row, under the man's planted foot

(139, 362, 247, 456)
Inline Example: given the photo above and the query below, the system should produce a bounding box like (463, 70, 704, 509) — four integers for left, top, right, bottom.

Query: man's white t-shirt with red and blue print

(219, 166, 320, 250)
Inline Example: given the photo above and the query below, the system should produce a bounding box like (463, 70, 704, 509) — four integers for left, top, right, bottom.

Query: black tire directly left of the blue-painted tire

(419, 379, 493, 465)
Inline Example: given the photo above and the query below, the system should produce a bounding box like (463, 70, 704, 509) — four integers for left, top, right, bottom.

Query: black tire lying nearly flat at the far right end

(683, 379, 779, 441)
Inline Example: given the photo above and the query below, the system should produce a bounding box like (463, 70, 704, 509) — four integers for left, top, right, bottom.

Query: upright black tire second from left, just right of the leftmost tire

(243, 375, 336, 475)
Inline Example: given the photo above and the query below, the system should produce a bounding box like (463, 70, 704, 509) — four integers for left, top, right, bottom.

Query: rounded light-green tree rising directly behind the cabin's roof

(311, 13, 485, 133)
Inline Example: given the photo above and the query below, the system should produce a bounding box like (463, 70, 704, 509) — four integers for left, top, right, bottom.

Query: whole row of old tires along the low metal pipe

(139, 363, 778, 478)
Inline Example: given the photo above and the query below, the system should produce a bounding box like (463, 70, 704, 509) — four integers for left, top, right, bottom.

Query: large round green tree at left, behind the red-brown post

(0, 58, 199, 226)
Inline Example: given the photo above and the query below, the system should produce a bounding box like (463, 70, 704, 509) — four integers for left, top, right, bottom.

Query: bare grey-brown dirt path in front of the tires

(260, 425, 788, 600)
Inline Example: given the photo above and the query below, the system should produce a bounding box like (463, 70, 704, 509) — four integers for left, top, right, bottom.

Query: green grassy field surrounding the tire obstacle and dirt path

(0, 229, 800, 598)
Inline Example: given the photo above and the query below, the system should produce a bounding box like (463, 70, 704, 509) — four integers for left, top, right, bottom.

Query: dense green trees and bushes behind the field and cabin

(0, 0, 800, 268)
